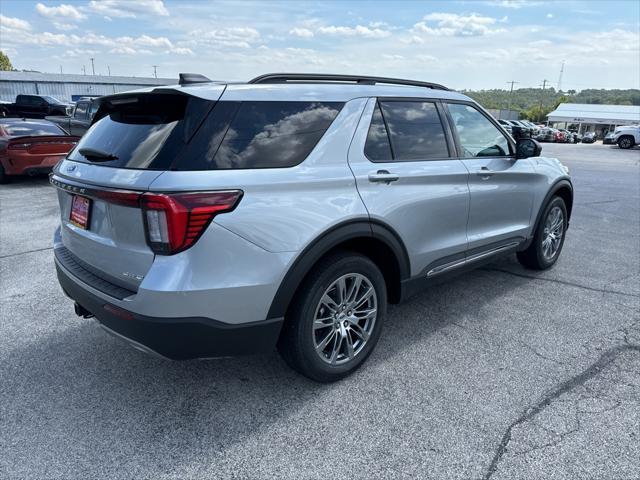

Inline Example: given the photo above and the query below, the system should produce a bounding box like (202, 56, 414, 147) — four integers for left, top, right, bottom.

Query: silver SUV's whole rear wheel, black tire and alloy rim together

(278, 252, 387, 382)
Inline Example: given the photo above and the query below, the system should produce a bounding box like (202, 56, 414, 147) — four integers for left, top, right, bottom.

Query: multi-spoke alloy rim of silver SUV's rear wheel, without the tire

(312, 273, 378, 365)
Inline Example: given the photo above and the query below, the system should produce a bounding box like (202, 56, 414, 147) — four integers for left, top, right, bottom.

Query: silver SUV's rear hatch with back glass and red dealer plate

(51, 85, 225, 297)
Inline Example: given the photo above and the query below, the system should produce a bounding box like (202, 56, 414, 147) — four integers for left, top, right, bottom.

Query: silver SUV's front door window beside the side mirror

(449, 103, 511, 157)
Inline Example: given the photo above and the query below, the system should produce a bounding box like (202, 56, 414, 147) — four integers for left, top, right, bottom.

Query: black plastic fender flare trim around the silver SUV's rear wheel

(267, 219, 411, 318)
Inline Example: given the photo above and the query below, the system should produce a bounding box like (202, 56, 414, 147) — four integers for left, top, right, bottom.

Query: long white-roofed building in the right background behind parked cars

(547, 103, 640, 137)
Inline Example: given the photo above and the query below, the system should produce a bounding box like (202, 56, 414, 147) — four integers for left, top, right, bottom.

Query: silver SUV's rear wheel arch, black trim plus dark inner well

(267, 220, 411, 318)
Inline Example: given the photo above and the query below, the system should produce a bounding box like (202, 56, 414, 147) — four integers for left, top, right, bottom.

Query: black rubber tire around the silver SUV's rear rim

(278, 251, 387, 383)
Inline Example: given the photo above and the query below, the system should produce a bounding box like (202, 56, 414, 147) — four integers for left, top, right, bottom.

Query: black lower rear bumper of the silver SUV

(56, 261, 283, 360)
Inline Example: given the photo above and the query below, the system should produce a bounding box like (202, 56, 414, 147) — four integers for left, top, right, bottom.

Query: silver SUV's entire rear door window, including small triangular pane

(365, 100, 449, 162)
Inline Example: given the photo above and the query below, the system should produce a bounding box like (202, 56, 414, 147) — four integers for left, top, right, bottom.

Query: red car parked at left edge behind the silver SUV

(0, 118, 80, 183)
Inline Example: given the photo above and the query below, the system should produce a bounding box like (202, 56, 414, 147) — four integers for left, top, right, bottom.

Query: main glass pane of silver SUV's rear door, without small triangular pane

(380, 101, 449, 160)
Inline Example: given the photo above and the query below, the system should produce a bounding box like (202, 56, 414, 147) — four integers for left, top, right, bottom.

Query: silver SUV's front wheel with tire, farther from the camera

(518, 197, 567, 270)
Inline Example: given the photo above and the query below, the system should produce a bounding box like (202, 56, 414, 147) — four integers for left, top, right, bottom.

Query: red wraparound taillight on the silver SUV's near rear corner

(140, 190, 242, 255)
